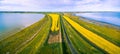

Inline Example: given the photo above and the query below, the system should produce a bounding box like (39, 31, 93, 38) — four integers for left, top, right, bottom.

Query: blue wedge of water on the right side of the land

(75, 12, 120, 26)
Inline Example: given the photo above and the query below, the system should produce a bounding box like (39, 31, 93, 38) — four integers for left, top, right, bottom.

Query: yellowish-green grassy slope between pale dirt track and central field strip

(17, 16, 51, 54)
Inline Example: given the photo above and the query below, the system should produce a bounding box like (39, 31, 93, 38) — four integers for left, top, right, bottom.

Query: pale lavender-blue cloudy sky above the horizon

(0, 0, 120, 11)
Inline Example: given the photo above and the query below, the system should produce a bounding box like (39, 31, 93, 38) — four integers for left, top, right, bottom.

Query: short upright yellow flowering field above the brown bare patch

(48, 14, 59, 31)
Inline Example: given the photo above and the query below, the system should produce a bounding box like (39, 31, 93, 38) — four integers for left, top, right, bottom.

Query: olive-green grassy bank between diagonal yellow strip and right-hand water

(65, 14, 120, 47)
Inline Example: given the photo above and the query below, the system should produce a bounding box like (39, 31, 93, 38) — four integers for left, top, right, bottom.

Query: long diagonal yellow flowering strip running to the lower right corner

(63, 16, 120, 54)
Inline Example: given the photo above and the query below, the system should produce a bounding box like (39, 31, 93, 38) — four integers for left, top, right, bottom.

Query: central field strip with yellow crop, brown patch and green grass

(35, 13, 63, 54)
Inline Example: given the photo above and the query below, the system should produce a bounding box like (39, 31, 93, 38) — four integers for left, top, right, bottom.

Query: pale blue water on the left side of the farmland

(0, 13, 44, 33)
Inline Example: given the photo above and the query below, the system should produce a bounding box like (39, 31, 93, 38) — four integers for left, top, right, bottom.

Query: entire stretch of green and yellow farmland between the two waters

(0, 13, 120, 54)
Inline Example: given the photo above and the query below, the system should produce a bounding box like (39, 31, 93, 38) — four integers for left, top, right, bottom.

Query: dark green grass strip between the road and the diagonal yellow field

(64, 19, 104, 54)
